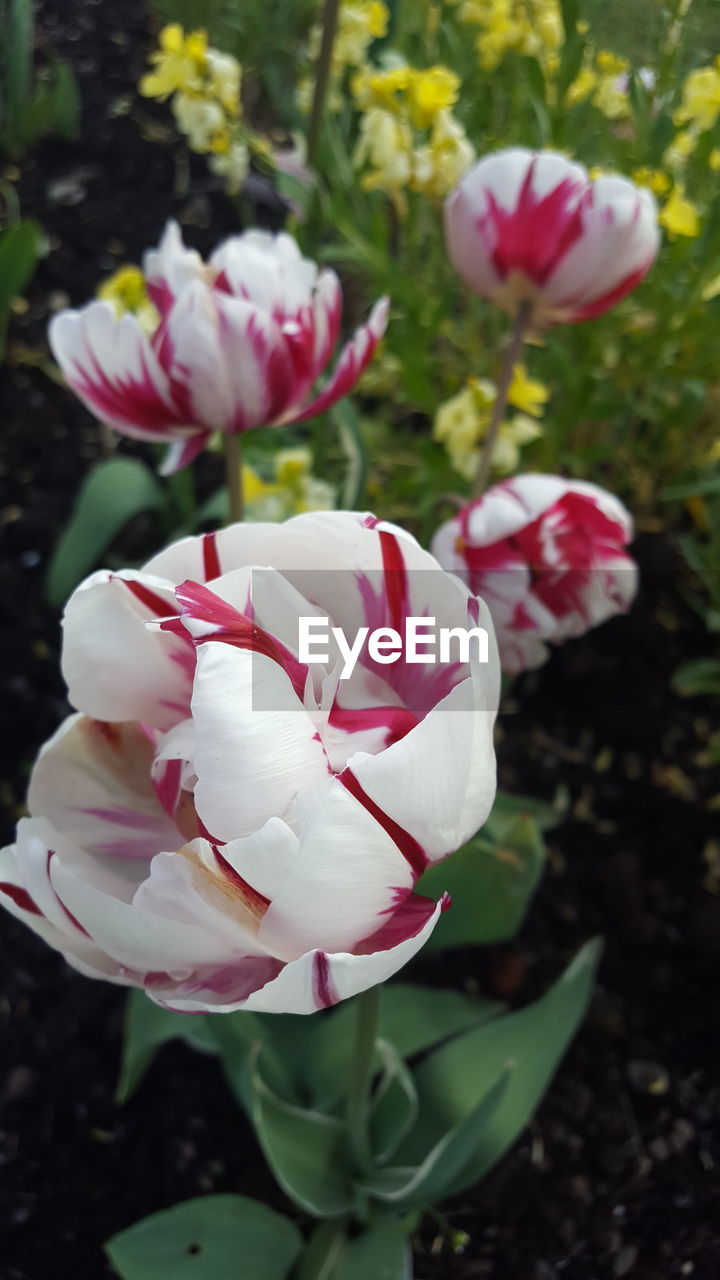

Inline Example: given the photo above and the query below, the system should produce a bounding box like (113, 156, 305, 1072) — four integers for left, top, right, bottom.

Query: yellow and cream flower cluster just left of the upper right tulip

(352, 65, 475, 218)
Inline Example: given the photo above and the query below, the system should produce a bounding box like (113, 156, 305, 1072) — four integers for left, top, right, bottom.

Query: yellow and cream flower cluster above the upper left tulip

(140, 22, 249, 191)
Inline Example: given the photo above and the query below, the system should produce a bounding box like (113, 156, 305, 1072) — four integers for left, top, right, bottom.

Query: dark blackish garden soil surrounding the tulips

(0, 0, 720, 1280)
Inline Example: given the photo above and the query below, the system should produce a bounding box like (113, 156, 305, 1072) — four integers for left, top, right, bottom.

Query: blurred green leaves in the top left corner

(0, 0, 81, 160)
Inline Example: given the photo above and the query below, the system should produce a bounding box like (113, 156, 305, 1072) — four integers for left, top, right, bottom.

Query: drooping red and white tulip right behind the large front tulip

(432, 475, 637, 673)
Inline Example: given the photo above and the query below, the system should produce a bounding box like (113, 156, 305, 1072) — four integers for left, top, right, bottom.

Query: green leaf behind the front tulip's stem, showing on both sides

(300, 982, 503, 1110)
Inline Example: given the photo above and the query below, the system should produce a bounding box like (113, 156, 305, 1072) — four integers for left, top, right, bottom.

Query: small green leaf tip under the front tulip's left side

(115, 991, 217, 1103)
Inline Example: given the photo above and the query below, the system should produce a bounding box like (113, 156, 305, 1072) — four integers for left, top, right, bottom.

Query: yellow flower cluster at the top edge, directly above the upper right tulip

(452, 0, 565, 72)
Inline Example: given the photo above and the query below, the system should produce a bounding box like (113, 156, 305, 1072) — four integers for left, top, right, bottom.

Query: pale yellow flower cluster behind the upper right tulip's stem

(433, 365, 550, 480)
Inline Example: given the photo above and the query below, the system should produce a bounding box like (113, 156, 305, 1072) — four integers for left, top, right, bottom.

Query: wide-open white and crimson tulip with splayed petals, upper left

(49, 223, 388, 474)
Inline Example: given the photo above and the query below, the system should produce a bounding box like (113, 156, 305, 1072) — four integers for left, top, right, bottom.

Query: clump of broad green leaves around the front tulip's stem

(198, 945, 597, 1223)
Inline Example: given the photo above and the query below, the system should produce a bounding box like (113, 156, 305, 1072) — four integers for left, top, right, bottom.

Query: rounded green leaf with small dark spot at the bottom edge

(105, 1196, 302, 1280)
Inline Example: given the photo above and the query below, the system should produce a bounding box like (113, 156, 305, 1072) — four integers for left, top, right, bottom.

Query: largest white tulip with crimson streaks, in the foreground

(0, 512, 500, 1012)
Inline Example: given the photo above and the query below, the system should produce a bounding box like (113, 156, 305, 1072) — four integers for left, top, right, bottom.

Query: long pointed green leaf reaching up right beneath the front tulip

(396, 941, 600, 1196)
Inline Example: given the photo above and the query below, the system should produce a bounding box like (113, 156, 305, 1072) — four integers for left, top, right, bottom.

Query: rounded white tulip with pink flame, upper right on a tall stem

(445, 147, 660, 329)
